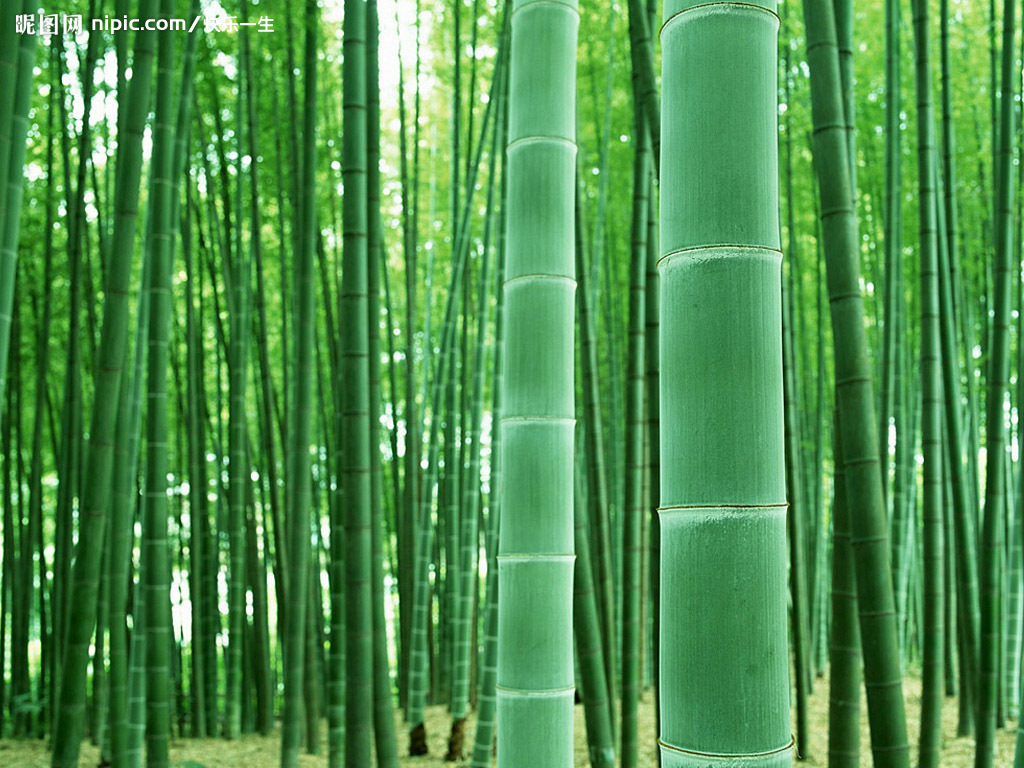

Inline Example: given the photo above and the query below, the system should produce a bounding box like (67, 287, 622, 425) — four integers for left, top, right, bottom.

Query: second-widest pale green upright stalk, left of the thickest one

(497, 0, 580, 768)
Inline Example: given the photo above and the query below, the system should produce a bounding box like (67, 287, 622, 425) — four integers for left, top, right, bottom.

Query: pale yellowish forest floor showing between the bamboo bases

(0, 675, 1016, 768)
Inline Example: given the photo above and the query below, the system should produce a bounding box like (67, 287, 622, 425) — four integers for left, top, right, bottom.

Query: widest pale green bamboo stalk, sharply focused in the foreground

(658, 0, 793, 768)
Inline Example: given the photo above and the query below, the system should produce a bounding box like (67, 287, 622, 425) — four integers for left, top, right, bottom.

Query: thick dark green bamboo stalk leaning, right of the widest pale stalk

(804, 0, 909, 768)
